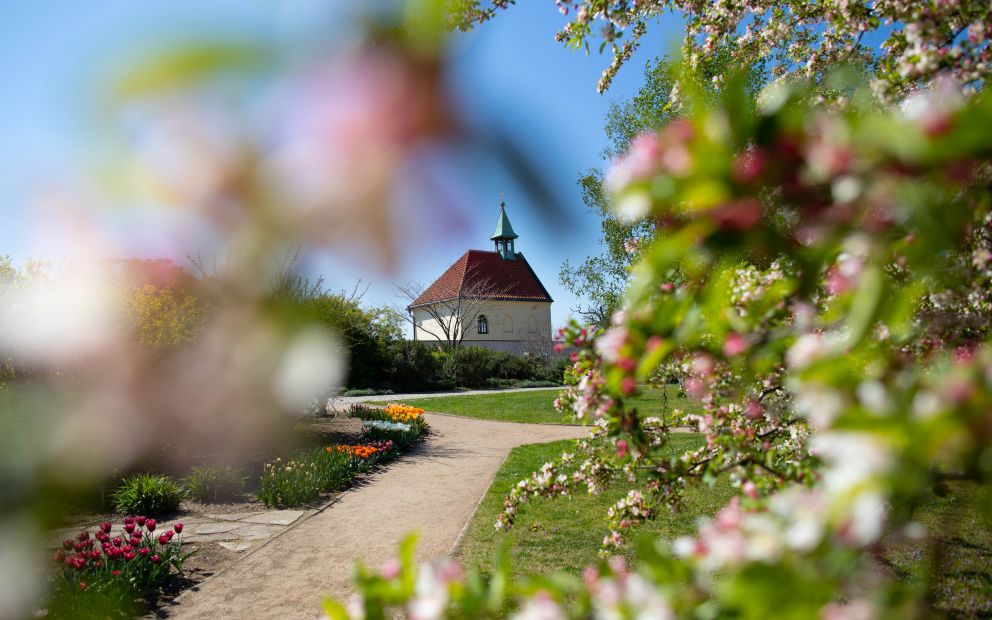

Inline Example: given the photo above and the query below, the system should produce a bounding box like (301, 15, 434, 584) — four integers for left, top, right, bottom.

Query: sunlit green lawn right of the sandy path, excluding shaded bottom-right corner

(456, 433, 735, 574)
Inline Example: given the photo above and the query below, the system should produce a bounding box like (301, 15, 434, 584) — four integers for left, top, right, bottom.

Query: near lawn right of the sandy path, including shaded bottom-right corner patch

(455, 433, 992, 618)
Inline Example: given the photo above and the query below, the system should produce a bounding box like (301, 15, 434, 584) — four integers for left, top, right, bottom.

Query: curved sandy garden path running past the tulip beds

(162, 414, 588, 620)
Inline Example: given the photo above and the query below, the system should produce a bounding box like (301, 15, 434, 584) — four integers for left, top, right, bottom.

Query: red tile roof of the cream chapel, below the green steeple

(409, 250, 554, 308)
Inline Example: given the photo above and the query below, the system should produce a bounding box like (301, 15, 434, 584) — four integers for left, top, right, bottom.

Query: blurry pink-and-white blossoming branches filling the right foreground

(336, 66, 992, 618)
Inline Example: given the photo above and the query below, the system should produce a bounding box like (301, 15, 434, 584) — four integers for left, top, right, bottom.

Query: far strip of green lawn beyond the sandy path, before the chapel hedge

(392, 385, 699, 424)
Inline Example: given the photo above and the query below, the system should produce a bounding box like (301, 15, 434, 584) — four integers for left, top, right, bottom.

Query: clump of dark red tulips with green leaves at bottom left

(45, 516, 193, 618)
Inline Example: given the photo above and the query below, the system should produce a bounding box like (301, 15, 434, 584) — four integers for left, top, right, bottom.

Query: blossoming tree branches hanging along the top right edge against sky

(449, 0, 992, 101)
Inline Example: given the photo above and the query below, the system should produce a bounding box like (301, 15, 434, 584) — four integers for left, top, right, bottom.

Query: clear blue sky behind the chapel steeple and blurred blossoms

(0, 0, 681, 324)
